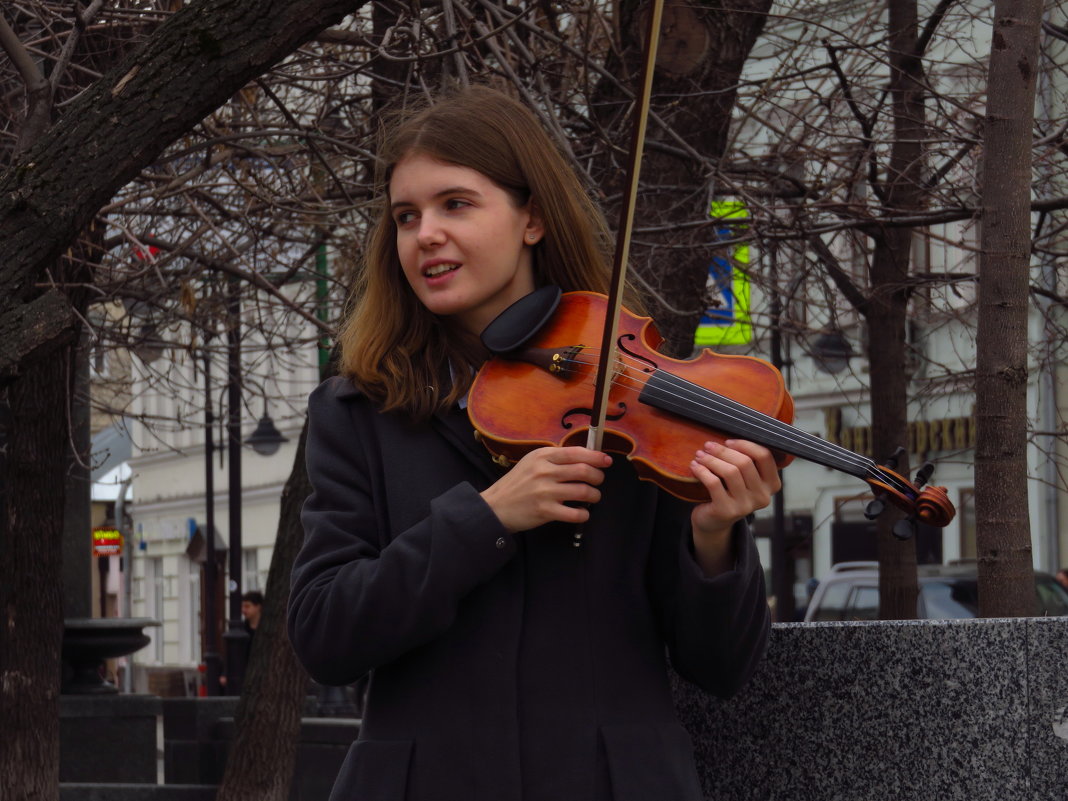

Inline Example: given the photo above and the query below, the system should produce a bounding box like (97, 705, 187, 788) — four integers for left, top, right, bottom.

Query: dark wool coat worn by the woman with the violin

(288, 378, 770, 801)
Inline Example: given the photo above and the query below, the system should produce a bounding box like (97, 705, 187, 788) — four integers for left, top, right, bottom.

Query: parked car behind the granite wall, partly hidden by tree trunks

(804, 562, 1068, 622)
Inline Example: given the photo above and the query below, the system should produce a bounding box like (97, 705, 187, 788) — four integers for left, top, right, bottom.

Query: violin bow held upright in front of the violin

(586, 0, 664, 451)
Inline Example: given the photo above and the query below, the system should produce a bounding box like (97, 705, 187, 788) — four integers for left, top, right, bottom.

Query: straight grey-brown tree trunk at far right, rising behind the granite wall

(975, 0, 1042, 617)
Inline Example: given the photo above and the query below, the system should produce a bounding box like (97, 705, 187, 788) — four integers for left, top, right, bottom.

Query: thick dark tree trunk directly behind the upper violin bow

(596, 0, 771, 357)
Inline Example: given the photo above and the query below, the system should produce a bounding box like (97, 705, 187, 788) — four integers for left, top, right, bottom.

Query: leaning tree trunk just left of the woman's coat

(217, 422, 311, 801)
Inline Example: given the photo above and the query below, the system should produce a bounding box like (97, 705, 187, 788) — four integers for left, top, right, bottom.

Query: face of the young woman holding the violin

(390, 153, 544, 334)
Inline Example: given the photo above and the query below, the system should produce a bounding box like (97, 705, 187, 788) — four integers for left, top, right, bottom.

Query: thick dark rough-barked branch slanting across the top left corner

(0, 0, 362, 380)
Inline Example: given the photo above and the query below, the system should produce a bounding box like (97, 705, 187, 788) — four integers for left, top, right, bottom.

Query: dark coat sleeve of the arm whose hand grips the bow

(288, 379, 516, 685)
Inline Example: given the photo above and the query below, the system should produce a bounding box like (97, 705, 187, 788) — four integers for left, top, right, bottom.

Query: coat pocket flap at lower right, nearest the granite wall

(601, 723, 705, 801)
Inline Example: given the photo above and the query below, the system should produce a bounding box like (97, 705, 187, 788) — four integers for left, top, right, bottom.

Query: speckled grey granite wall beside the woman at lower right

(675, 617, 1068, 801)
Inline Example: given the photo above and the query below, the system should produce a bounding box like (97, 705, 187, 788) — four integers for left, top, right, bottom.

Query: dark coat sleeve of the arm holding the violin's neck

(649, 496, 771, 697)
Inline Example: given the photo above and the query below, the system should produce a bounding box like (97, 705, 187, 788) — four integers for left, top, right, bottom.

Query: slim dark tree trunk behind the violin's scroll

(865, 0, 925, 621)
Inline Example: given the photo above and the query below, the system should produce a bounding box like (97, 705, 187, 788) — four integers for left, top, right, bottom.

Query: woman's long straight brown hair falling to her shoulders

(339, 87, 623, 419)
